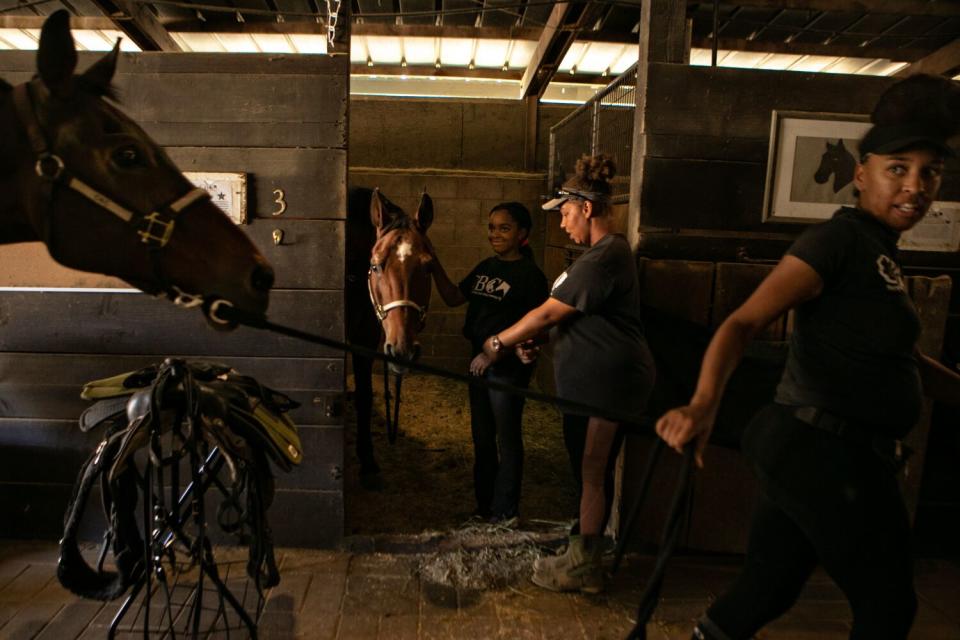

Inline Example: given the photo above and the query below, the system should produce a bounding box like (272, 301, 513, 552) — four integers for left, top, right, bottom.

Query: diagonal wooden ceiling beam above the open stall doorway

(520, 0, 604, 98)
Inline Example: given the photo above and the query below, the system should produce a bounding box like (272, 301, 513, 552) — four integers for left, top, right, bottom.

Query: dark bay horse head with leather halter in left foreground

(0, 10, 273, 324)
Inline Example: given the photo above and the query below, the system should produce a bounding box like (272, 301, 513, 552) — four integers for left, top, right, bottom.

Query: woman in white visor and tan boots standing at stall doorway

(483, 156, 654, 593)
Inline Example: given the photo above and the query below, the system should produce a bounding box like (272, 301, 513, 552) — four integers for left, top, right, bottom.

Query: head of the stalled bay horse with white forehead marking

(367, 190, 433, 372)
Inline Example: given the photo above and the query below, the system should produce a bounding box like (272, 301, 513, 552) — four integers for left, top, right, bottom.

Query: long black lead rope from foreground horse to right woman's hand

(208, 301, 696, 640)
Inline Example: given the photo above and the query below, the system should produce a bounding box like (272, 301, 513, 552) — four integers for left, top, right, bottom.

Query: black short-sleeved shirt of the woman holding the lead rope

(776, 207, 922, 438)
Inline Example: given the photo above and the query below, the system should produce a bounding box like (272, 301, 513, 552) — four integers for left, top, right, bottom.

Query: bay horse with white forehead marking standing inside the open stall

(345, 188, 433, 488)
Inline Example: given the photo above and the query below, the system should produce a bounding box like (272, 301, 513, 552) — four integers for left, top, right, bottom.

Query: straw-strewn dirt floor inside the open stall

(344, 373, 576, 535)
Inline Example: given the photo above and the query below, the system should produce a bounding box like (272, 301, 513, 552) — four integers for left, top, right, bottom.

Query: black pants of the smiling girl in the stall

(470, 360, 533, 518)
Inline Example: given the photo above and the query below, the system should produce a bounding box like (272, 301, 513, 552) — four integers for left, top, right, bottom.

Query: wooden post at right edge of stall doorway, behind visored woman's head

(627, 0, 690, 247)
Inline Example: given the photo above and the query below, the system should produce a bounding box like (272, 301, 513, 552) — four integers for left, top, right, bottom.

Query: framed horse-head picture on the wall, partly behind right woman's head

(763, 110, 870, 223)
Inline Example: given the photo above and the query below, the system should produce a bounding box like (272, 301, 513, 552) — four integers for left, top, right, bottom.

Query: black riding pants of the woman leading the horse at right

(707, 405, 917, 640)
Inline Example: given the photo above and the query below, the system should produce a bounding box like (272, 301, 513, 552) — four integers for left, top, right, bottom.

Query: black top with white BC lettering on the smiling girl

(458, 256, 547, 353)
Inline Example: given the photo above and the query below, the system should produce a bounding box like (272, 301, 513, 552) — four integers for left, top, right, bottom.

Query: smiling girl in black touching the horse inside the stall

(433, 202, 547, 524)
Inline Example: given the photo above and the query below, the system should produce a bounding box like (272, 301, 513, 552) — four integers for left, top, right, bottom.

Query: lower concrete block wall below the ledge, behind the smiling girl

(349, 169, 546, 372)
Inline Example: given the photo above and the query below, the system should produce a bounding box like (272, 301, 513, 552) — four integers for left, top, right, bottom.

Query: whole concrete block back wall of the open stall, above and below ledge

(348, 98, 572, 371)
